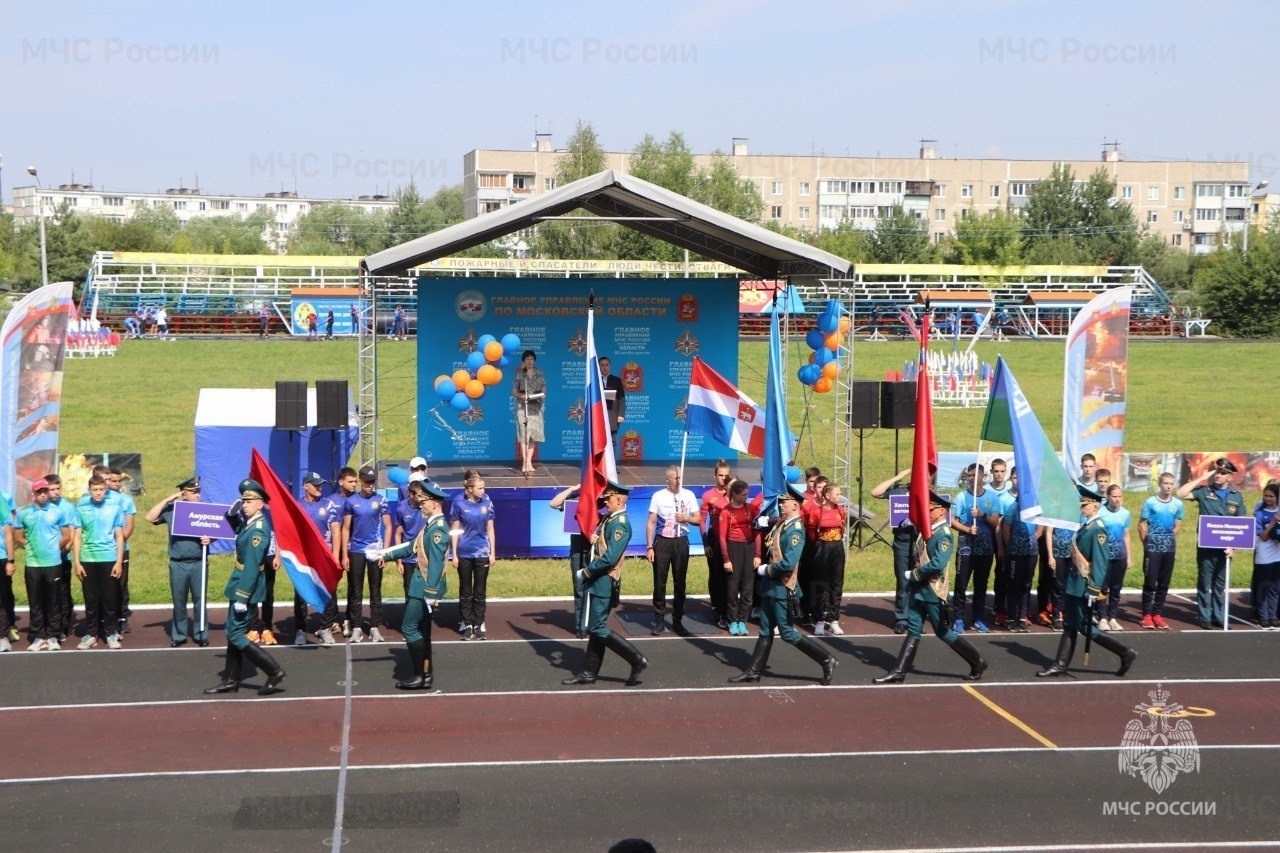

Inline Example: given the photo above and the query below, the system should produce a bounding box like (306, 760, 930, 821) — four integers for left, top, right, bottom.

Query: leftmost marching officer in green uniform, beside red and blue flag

(205, 479, 284, 695)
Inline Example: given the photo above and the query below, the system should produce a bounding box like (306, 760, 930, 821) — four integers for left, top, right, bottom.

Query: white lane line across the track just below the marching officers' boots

(0, 670, 1280, 724)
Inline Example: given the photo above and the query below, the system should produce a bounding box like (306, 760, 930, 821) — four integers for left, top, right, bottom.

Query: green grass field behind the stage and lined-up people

(35, 339, 1280, 602)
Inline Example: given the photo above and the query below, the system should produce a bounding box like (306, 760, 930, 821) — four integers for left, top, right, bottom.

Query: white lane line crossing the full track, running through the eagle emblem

(0, 743, 1280, 783)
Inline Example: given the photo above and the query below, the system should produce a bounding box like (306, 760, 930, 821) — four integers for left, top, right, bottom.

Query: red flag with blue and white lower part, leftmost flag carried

(248, 447, 342, 610)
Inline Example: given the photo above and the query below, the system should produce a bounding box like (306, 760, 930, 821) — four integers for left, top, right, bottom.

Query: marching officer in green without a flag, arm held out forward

(367, 480, 449, 690)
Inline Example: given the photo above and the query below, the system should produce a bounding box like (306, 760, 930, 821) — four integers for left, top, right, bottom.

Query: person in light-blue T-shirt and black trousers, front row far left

(72, 476, 124, 651)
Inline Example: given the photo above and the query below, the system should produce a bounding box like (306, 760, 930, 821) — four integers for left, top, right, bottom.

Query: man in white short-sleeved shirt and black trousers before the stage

(645, 465, 703, 637)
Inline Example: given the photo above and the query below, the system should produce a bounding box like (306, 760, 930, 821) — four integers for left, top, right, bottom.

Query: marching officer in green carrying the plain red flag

(872, 492, 987, 684)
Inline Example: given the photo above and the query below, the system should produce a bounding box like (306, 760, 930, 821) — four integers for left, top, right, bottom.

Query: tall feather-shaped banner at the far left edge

(0, 282, 72, 506)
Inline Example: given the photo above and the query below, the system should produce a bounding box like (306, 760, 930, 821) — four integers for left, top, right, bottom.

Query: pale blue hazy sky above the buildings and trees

(0, 0, 1280, 200)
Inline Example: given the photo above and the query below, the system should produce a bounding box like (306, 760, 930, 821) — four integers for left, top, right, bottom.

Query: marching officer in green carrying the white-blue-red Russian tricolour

(561, 482, 649, 686)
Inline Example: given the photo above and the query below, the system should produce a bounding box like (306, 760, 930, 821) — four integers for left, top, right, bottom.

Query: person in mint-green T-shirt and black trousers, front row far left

(14, 478, 72, 652)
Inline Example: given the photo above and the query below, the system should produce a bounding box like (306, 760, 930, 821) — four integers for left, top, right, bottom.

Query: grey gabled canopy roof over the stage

(360, 169, 851, 278)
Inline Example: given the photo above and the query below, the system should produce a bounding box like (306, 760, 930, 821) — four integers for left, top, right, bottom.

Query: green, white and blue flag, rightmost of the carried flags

(977, 356, 1080, 530)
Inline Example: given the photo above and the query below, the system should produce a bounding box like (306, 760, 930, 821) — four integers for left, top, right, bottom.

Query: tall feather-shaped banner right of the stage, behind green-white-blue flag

(1062, 287, 1133, 478)
